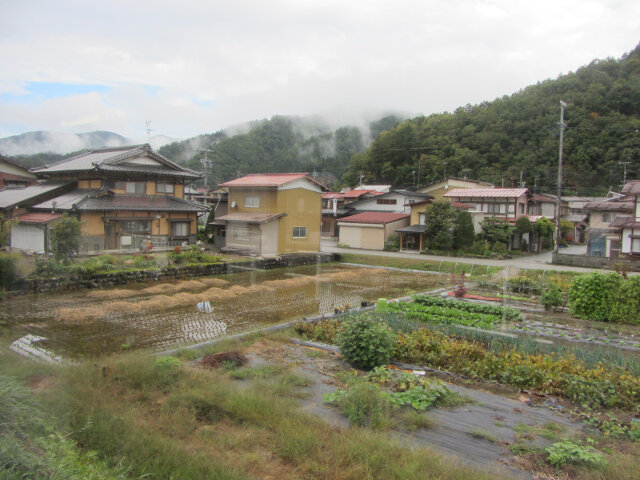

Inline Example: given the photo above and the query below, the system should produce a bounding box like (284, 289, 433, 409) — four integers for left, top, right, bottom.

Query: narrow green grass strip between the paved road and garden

(341, 253, 502, 278)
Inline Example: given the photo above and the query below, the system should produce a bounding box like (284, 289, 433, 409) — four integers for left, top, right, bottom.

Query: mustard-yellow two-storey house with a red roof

(216, 173, 328, 256)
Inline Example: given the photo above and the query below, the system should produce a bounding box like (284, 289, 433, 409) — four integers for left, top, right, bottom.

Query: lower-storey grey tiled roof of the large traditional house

(32, 189, 208, 212)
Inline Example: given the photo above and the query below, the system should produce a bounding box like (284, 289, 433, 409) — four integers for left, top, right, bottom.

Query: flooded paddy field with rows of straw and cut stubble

(0, 264, 442, 357)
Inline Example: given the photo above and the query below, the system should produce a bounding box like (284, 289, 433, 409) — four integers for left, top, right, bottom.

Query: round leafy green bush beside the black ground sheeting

(338, 315, 395, 370)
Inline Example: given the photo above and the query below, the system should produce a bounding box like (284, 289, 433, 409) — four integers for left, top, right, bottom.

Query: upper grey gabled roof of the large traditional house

(30, 144, 203, 178)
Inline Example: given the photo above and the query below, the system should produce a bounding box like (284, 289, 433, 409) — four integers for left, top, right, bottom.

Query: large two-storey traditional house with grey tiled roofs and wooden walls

(12, 145, 207, 253)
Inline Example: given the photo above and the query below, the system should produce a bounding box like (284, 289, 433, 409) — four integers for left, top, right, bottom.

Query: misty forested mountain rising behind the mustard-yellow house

(159, 115, 401, 185)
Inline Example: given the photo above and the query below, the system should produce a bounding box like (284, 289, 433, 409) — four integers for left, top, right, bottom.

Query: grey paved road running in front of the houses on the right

(320, 242, 604, 273)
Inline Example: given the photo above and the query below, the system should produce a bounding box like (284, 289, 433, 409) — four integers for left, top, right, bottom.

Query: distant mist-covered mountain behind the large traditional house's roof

(0, 131, 134, 155)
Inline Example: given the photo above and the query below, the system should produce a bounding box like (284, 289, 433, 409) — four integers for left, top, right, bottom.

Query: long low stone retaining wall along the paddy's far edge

(12, 253, 335, 295)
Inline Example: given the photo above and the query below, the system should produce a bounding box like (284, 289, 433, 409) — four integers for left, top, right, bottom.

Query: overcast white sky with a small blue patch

(0, 0, 640, 140)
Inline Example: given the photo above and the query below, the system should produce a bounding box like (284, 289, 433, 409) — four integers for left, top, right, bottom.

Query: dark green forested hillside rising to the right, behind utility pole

(344, 45, 640, 194)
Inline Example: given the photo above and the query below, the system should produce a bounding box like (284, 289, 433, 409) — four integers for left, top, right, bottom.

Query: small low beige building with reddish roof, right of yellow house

(338, 211, 410, 250)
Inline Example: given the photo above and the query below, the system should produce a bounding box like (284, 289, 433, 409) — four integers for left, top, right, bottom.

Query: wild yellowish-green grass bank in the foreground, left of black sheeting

(22, 353, 504, 479)
